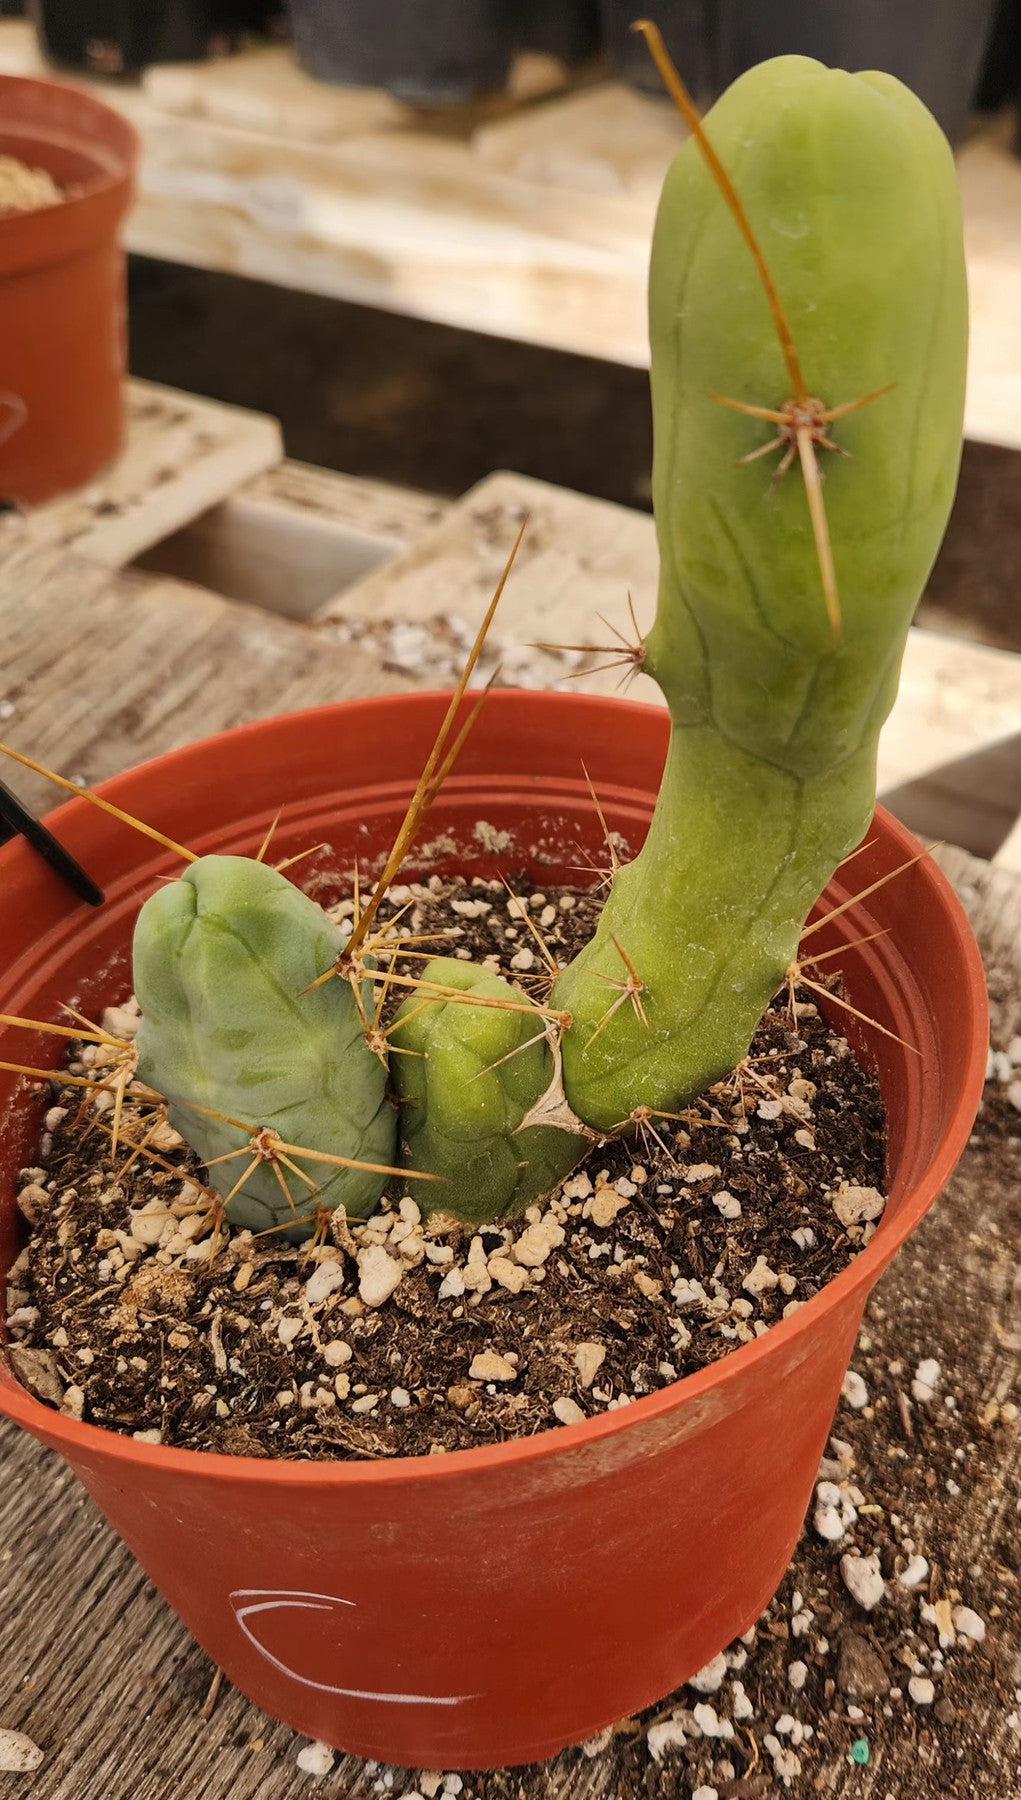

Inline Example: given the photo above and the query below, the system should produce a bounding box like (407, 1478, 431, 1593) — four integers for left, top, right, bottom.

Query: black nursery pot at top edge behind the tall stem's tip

(601, 0, 996, 144)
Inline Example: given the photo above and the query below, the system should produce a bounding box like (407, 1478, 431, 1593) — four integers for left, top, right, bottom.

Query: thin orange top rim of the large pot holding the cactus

(0, 688, 989, 1489)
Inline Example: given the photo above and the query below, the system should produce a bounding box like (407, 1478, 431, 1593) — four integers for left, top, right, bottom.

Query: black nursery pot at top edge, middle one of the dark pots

(290, 0, 515, 106)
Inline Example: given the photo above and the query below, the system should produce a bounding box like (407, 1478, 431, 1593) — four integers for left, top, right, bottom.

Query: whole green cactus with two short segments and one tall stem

(127, 56, 967, 1226)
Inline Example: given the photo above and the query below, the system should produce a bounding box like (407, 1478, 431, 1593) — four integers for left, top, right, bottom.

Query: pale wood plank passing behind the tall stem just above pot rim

(321, 475, 1021, 851)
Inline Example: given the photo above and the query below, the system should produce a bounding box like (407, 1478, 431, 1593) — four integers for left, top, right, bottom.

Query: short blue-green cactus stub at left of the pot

(133, 857, 396, 1237)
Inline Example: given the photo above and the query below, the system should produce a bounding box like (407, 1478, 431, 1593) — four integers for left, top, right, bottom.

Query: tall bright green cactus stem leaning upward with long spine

(553, 56, 967, 1129)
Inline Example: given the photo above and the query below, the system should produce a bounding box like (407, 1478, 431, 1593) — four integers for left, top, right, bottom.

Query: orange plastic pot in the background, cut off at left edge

(0, 76, 139, 506)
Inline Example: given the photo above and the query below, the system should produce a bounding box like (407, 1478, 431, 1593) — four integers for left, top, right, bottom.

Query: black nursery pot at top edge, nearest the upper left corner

(29, 0, 214, 76)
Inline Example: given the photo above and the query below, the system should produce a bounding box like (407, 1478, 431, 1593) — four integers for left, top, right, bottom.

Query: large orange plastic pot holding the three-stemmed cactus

(0, 691, 987, 1768)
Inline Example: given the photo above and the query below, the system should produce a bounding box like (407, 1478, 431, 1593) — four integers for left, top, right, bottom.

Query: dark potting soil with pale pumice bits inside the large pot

(9, 877, 886, 1460)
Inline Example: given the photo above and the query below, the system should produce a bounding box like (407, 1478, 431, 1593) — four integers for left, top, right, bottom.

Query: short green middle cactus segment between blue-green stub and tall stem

(393, 958, 589, 1224)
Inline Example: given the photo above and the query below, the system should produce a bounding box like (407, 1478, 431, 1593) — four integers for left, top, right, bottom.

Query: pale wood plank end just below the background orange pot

(0, 382, 283, 569)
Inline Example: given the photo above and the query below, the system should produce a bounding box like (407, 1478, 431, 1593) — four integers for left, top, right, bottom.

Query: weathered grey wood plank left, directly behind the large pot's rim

(0, 549, 402, 812)
